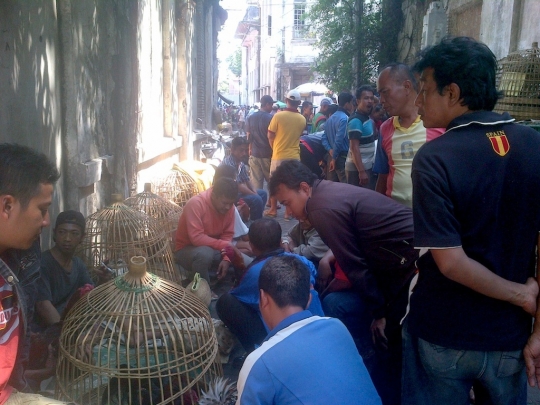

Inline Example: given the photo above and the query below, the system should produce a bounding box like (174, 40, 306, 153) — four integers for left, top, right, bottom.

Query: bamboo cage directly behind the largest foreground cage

(75, 194, 182, 283)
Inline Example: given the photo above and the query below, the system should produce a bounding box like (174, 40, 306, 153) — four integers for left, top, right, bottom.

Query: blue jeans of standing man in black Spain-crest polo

(402, 321, 527, 405)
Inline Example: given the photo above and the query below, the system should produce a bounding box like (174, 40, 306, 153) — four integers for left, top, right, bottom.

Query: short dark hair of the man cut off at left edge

(0, 143, 60, 209)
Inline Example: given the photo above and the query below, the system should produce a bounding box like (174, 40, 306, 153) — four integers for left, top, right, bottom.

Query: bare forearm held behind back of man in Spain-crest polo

(431, 247, 538, 315)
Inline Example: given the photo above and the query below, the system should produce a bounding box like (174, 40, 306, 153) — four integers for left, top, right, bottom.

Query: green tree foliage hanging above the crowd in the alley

(309, 0, 391, 92)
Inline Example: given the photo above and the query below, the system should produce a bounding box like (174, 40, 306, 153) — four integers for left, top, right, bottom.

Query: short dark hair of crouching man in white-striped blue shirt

(259, 255, 311, 309)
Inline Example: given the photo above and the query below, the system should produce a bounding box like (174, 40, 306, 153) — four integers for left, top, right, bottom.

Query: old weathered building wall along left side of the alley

(0, 0, 226, 246)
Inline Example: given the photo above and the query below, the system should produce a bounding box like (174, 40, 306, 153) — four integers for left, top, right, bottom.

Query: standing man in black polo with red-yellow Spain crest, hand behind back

(402, 37, 540, 405)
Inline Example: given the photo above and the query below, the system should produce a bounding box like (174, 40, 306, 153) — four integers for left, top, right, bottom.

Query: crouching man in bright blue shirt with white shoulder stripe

(237, 255, 381, 405)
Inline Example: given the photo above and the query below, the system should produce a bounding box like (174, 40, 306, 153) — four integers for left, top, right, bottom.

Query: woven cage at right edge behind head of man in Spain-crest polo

(495, 42, 540, 120)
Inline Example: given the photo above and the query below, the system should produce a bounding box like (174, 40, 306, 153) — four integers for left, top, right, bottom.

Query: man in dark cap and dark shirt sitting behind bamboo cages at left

(36, 210, 112, 326)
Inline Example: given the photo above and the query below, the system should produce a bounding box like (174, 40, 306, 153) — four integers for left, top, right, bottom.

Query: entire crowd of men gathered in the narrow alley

(0, 37, 540, 405)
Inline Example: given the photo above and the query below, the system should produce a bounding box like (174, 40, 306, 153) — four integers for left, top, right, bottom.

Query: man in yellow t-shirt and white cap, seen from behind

(264, 90, 306, 220)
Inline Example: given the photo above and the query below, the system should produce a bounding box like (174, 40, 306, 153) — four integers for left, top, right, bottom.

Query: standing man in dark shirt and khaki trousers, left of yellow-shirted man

(246, 95, 274, 189)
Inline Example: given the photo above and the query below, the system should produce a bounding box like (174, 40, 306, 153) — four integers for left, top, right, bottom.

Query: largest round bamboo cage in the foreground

(56, 256, 223, 405)
